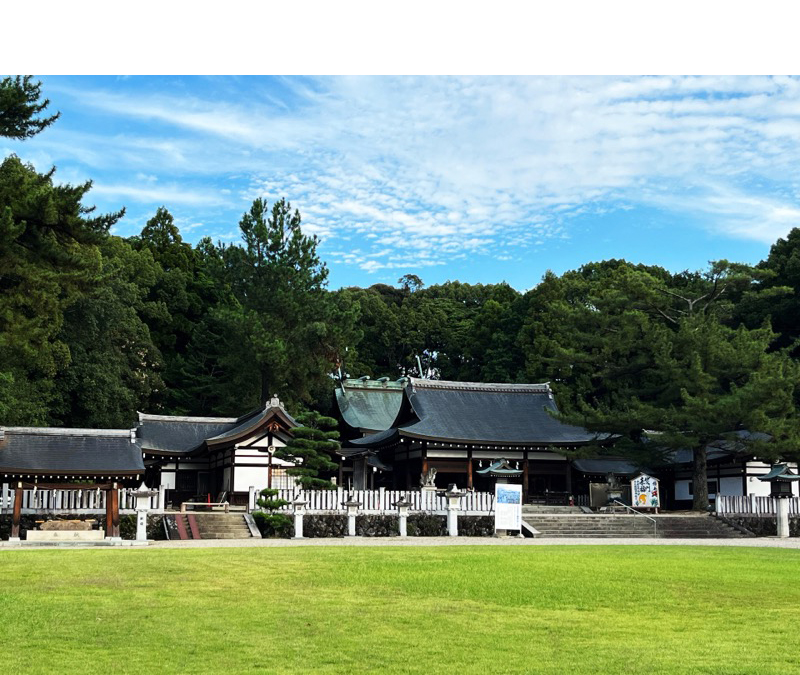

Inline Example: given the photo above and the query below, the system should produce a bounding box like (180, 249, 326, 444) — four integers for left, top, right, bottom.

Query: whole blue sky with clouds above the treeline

(6, 76, 800, 290)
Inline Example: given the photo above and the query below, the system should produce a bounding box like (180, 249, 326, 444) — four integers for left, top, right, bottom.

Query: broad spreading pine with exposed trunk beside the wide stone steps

(529, 261, 800, 510)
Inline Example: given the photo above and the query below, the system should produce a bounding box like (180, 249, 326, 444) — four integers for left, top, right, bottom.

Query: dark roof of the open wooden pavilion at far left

(0, 427, 144, 477)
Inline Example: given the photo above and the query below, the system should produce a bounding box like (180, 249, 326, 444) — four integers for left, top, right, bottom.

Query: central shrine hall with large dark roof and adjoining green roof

(336, 378, 609, 498)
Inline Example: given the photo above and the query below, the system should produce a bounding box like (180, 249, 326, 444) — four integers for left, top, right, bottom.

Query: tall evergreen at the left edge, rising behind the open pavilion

(0, 156, 124, 424)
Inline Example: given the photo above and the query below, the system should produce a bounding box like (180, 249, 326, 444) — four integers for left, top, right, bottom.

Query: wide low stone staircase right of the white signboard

(522, 507, 748, 539)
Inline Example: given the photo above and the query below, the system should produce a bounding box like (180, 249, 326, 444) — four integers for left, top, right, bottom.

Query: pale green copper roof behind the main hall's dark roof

(336, 378, 406, 432)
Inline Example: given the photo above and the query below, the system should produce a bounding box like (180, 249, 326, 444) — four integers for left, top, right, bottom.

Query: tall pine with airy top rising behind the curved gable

(222, 199, 354, 410)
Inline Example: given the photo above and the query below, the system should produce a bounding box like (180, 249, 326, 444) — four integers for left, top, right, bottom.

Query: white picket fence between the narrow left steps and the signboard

(253, 488, 494, 516)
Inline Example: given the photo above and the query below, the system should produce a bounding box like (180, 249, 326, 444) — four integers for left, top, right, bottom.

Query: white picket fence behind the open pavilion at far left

(0, 483, 165, 515)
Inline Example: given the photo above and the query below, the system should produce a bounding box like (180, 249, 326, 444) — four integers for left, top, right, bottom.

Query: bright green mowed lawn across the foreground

(0, 546, 800, 675)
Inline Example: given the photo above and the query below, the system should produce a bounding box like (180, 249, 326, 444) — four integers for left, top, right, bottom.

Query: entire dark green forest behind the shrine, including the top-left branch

(0, 78, 800, 508)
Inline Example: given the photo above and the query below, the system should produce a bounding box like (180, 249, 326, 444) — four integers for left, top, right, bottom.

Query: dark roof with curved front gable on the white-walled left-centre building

(136, 398, 298, 455)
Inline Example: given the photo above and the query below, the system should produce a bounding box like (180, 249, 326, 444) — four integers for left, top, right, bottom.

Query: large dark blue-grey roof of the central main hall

(350, 378, 598, 447)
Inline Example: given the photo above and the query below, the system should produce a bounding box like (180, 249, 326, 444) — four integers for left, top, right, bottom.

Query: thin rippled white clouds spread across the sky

(28, 76, 800, 272)
